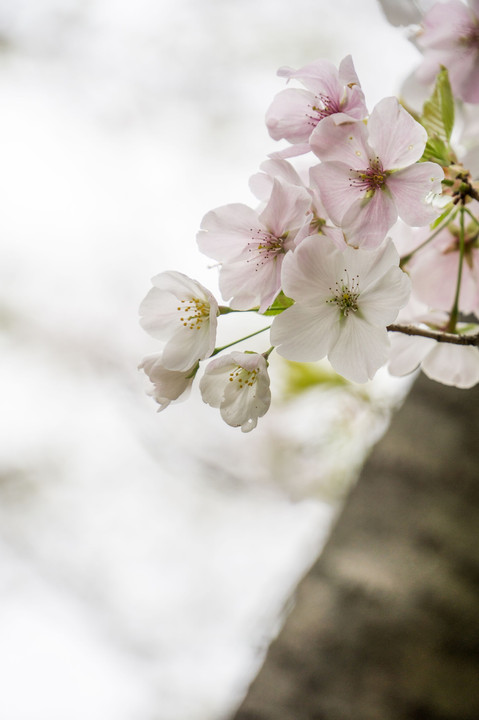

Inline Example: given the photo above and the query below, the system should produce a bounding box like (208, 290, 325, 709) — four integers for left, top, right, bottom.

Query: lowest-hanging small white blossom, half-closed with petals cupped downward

(200, 352, 271, 432)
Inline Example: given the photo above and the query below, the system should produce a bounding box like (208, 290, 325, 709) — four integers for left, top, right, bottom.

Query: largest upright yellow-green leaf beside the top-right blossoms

(419, 67, 454, 158)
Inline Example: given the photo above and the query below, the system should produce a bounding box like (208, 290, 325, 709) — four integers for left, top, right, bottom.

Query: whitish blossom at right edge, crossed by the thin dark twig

(388, 313, 479, 389)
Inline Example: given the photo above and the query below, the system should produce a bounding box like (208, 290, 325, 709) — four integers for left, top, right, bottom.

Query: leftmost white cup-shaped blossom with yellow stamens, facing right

(140, 271, 219, 372)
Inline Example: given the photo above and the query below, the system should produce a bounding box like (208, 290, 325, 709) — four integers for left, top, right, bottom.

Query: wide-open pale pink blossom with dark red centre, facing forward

(311, 97, 444, 247)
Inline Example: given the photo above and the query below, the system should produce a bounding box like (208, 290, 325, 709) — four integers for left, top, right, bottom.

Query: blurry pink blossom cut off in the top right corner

(416, 0, 479, 103)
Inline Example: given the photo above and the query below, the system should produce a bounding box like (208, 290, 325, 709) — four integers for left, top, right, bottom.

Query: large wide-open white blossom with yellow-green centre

(271, 236, 410, 382)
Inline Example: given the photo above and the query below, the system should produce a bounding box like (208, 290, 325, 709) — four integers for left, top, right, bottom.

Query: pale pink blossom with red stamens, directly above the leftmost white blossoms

(197, 178, 311, 312)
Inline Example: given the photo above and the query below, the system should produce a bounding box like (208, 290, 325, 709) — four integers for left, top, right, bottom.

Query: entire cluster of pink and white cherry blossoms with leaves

(140, 0, 479, 432)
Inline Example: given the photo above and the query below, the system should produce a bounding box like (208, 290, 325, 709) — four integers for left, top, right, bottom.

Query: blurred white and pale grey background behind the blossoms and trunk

(0, 0, 418, 720)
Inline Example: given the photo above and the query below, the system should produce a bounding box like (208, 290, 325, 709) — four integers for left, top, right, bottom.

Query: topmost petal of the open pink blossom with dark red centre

(368, 97, 427, 170)
